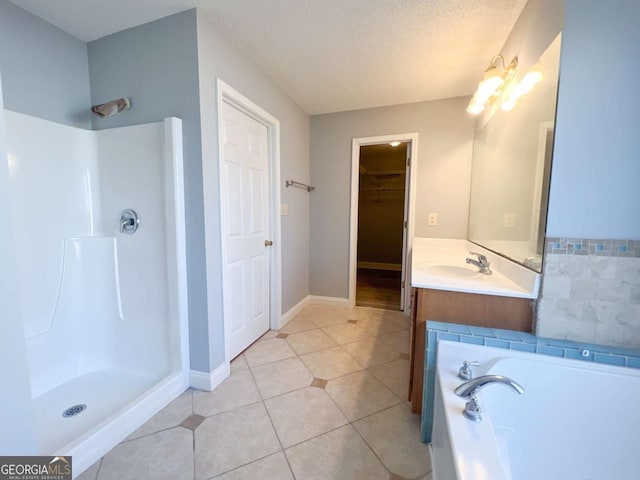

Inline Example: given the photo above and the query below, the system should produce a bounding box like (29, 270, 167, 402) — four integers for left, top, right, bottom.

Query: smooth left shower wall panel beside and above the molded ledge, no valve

(5, 110, 100, 338)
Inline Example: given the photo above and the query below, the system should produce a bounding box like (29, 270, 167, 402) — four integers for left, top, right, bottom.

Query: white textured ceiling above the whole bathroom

(12, 0, 526, 114)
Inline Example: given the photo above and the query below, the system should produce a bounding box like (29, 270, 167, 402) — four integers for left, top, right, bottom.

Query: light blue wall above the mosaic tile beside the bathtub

(547, 0, 640, 240)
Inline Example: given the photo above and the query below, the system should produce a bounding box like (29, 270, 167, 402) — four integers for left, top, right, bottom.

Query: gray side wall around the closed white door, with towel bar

(198, 13, 316, 366)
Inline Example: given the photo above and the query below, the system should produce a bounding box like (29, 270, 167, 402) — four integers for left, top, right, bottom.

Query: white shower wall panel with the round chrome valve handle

(93, 123, 180, 373)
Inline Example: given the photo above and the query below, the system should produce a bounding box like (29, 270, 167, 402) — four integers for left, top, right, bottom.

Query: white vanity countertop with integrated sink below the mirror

(411, 237, 540, 299)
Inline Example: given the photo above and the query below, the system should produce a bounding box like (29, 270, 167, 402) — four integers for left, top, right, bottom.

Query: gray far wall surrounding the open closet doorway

(310, 97, 474, 298)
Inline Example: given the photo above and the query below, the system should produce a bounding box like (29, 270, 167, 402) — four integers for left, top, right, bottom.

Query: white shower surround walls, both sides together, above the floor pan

(6, 111, 178, 390)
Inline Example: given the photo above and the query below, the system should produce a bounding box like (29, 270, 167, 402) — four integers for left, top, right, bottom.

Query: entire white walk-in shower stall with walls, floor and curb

(0, 103, 188, 473)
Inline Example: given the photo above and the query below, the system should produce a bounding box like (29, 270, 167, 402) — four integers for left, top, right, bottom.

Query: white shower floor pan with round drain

(33, 369, 161, 455)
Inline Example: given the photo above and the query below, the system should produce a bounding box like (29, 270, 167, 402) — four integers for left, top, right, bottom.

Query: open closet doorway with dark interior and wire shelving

(349, 136, 415, 311)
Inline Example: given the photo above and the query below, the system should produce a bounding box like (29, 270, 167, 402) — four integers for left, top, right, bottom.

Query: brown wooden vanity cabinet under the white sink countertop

(408, 288, 533, 413)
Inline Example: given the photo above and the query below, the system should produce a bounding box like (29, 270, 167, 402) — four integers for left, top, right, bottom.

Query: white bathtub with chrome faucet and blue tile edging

(431, 341, 640, 480)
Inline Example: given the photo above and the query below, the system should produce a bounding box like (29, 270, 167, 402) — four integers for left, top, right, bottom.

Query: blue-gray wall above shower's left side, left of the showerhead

(0, 0, 91, 128)
